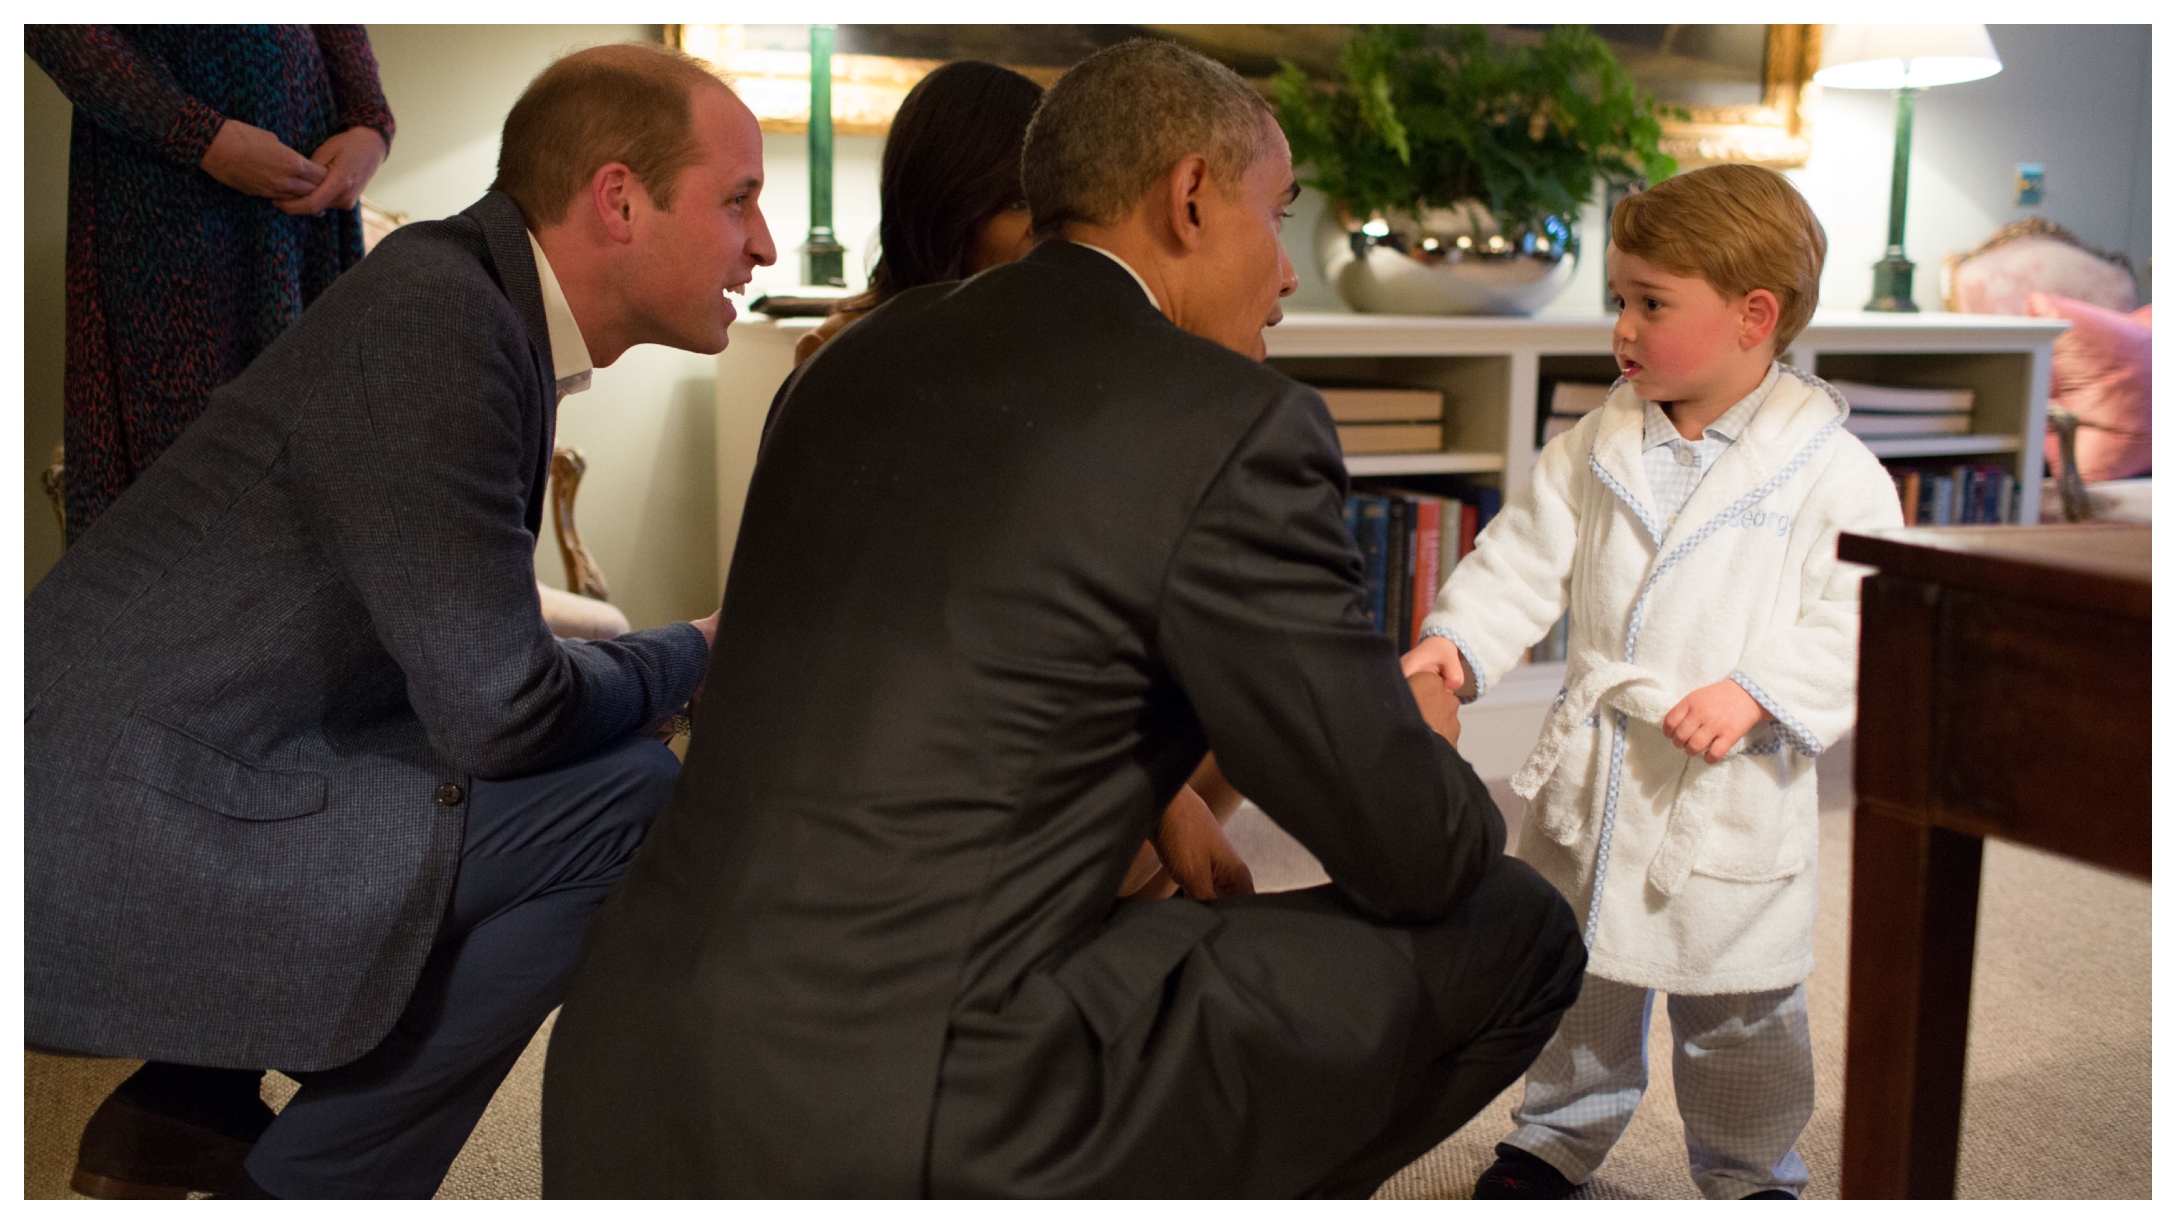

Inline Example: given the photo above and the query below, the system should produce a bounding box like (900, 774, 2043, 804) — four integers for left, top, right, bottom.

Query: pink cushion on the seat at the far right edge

(2026, 294, 2154, 481)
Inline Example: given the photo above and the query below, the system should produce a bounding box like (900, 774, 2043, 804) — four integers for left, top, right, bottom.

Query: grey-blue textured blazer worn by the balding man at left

(24, 194, 705, 1069)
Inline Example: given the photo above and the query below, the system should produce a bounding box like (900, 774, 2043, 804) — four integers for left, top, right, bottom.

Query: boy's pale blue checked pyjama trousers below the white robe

(1506, 976, 1813, 1198)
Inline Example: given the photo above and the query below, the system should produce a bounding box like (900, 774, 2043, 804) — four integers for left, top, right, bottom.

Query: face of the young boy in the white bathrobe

(1608, 246, 1778, 407)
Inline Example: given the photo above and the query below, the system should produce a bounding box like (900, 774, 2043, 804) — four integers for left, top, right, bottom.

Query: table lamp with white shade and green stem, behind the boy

(1813, 26, 2002, 311)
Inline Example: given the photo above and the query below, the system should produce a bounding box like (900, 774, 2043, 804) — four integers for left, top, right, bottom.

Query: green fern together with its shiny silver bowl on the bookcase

(1271, 26, 1678, 314)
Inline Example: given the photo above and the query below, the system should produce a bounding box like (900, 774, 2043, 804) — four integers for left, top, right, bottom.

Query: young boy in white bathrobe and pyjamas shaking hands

(1406, 166, 1902, 1198)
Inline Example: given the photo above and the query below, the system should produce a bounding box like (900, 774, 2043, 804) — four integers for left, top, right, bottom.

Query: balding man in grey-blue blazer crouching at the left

(24, 46, 775, 1198)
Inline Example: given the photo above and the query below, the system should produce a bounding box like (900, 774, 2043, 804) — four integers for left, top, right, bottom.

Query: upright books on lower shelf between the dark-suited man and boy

(1345, 481, 1504, 651)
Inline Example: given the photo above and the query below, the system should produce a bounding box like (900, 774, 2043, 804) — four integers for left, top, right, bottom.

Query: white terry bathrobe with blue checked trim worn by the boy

(1423, 366, 1902, 995)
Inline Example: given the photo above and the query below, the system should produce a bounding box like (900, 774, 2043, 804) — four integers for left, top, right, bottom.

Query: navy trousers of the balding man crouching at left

(246, 738, 679, 1198)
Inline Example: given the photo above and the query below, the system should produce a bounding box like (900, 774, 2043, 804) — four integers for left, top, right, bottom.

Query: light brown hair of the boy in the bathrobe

(1610, 166, 1828, 357)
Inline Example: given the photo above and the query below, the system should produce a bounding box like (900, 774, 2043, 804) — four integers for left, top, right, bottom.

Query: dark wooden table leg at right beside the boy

(1843, 804, 1980, 1198)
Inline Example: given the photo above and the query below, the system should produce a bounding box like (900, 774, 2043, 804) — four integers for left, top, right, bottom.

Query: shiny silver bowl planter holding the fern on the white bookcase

(1314, 200, 1580, 314)
